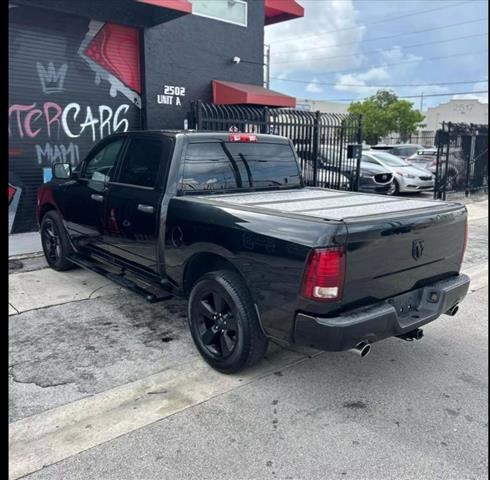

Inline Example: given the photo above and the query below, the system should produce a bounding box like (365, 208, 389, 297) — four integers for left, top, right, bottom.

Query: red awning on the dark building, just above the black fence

(213, 80, 296, 108)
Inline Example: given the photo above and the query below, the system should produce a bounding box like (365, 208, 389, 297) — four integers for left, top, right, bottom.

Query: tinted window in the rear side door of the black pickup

(118, 137, 172, 188)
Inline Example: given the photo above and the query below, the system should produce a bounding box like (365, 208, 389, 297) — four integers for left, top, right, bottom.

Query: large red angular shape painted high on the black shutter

(84, 23, 141, 93)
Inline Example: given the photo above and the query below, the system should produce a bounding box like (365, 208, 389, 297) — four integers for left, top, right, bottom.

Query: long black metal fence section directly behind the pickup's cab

(190, 101, 362, 190)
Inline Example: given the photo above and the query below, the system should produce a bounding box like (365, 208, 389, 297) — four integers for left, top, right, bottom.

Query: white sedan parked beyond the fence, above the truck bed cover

(362, 150, 434, 195)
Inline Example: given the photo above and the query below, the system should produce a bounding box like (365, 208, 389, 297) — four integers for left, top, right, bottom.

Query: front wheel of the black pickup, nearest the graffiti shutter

(41, 210, 76, 272)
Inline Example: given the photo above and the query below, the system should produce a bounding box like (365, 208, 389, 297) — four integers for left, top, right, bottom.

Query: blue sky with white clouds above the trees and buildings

(265, 0, 488, 110)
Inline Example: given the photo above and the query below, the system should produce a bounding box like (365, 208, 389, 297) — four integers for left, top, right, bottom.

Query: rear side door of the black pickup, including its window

(104, 134, 173, 272)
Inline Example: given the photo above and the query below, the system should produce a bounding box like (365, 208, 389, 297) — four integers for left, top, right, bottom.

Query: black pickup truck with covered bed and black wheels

(37, 131, 469, 373)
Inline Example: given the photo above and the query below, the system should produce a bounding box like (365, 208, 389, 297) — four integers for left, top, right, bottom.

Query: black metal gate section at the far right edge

(434, 122, 488, 200)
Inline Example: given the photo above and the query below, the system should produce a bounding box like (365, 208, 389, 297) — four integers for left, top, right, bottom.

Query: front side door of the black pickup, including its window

(61, 136, 125, 246)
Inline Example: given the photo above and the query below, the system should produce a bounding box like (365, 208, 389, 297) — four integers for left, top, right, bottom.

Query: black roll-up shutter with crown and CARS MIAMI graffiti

(8, 4, 141, 233)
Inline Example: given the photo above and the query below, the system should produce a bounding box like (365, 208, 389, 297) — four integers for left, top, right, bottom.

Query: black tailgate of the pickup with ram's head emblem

(338, 206, 466, 304)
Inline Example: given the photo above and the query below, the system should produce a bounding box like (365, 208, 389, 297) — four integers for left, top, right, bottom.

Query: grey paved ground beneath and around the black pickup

(9, 202, 488, 480)
